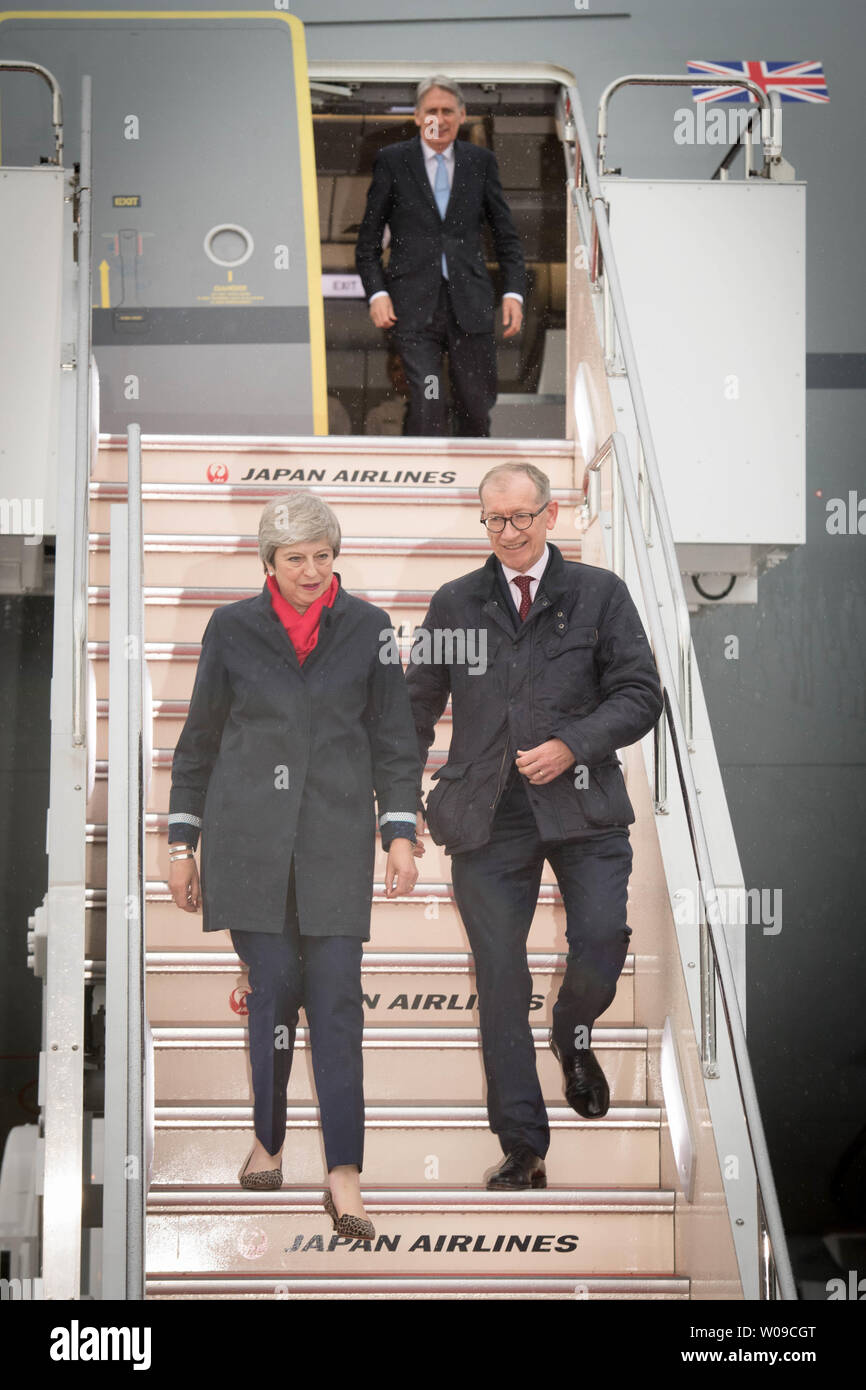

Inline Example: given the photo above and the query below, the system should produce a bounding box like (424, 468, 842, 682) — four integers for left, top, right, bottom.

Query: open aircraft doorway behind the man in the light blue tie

(310, 74, 567, 439)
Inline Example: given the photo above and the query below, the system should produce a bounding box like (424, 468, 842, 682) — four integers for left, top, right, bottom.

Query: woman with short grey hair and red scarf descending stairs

(168, 489, 423, 1240)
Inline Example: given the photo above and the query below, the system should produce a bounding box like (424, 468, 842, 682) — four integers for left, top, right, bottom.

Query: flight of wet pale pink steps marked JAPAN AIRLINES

(88, 439, 689, 1300)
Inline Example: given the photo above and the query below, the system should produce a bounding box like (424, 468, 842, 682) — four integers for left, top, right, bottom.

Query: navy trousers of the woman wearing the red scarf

(231, 865, 364, 1172)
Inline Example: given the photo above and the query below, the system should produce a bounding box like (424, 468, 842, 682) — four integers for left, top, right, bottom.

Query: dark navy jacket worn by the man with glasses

(406, 542, 663, 853)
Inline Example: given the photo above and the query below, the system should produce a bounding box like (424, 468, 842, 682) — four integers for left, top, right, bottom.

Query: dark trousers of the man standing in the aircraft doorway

(391, 277, 496, 438)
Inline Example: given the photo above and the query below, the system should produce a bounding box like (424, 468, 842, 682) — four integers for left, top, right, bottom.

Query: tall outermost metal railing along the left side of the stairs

(30, 63, 92, 1300)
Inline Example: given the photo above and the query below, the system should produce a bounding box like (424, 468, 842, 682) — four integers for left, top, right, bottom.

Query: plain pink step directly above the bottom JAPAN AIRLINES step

(153, 1104, 662, 1190)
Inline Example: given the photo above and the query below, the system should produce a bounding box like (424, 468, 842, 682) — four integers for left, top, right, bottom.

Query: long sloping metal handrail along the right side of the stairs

(564, 76, 796, 1300)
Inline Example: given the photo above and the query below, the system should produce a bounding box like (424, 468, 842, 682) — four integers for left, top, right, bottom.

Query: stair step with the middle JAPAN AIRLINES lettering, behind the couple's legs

(147, 949, 634, 1027)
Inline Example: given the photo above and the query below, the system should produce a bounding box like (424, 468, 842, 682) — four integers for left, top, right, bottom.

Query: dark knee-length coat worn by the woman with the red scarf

(168, 575, 421, 940)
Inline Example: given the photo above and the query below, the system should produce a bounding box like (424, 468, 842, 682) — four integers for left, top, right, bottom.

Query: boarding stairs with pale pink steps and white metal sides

(0, 62, 796, 1300)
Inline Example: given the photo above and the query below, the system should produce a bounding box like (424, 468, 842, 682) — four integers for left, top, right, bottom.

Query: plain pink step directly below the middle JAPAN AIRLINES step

(153, 1026, 646, 1106)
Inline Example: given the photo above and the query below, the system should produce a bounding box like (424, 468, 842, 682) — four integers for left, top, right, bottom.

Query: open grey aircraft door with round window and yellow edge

(0, 14, 327, 435)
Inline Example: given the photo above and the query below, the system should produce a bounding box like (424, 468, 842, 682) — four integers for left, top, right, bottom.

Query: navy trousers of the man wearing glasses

(452, 769, 632, 1158)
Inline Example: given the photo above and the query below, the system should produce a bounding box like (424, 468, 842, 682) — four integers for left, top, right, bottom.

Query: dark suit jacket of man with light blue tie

(354, 135, 525, 334)
